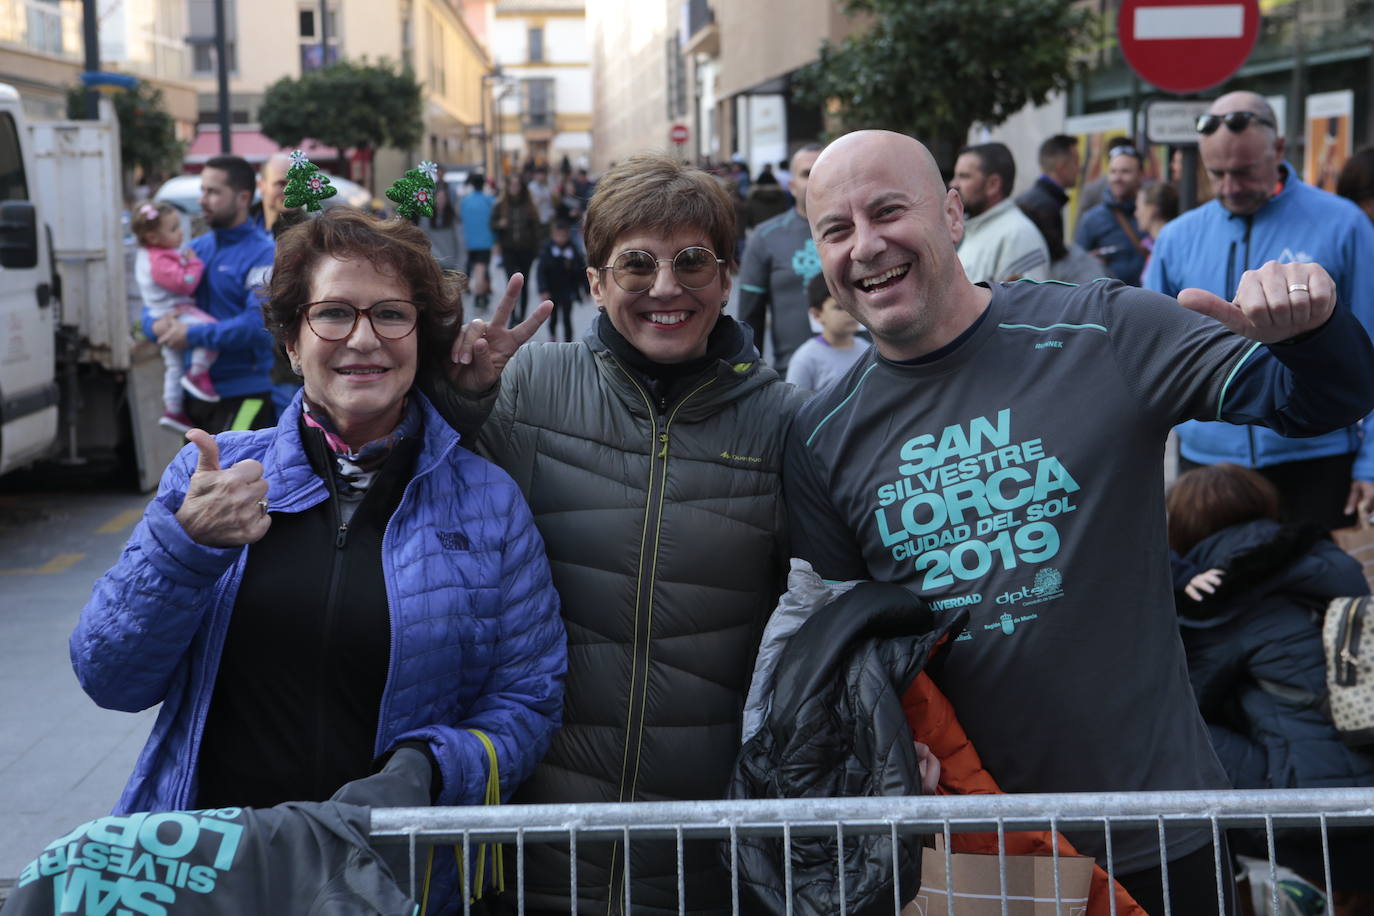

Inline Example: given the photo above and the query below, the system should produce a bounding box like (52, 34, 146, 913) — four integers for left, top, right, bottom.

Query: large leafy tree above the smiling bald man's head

(794, 0, 1096, 168)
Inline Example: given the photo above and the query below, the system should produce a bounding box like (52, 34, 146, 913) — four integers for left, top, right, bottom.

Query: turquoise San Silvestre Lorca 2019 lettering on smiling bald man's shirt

(874, 408, 1079, 593)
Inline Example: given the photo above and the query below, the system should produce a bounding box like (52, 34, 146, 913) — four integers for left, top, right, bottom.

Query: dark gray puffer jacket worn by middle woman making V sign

(464, 316, 804, 913)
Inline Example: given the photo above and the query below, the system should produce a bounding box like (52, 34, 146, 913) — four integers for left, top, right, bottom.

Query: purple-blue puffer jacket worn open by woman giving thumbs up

(70, 391, 567, 814)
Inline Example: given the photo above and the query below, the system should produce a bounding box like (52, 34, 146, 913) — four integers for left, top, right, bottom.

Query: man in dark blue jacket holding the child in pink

(144, 157, 276, 434)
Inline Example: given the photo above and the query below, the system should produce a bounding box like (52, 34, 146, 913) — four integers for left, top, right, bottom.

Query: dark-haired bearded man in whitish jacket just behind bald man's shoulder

(949, 143, 1050, 283)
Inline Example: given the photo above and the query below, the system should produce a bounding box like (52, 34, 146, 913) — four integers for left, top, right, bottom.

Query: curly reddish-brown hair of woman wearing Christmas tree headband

(262, 207, 467, 368)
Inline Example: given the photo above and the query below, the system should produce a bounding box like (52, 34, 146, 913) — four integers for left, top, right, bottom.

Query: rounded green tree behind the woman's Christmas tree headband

(258, 60, 425, 193)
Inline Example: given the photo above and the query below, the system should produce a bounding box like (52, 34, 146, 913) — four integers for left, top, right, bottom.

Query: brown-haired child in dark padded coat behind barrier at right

(1167, 463, 1374, 891)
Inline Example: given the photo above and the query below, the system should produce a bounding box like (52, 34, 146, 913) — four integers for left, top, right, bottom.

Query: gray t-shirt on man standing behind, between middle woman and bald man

(739, 209, 820, 375)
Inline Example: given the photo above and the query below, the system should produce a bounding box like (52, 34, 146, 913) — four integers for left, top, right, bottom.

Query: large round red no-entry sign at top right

(1117, 0, 1260, 93)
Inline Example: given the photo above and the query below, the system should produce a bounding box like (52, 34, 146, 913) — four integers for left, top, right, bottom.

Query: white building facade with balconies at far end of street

(489, 0, 592, 172)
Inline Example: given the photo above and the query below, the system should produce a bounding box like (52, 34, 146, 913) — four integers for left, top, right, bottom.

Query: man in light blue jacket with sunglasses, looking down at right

(1145, 92, 1374, 529)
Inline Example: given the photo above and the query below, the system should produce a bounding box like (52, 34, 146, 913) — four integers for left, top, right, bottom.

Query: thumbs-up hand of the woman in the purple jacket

(176, 430, 272, 547)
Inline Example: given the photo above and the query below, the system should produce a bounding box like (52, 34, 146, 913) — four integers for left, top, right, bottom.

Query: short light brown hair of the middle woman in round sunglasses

(583, 154, 735, 269)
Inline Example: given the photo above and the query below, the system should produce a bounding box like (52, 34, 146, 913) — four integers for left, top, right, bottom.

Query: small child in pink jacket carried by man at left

(131, 202, 220, 433)
